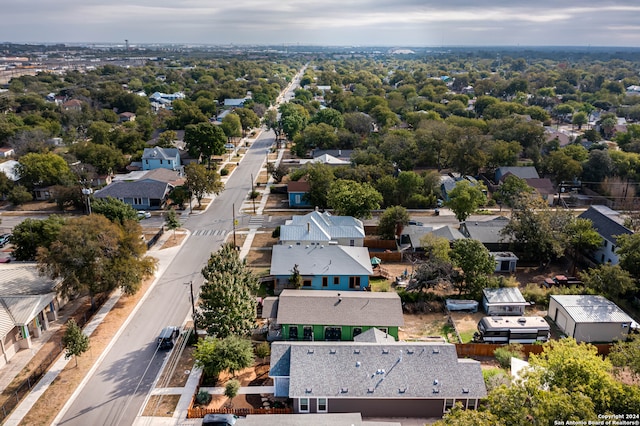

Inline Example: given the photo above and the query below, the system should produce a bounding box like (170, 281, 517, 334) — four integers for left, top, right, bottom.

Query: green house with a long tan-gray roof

(263, 283, 404, 341)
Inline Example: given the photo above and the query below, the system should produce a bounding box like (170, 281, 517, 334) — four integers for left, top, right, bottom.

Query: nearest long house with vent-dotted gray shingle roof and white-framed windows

(269, 338, 487, 418)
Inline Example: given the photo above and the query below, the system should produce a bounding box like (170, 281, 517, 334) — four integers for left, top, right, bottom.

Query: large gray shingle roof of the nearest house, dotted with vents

(270, 342, 487, 399)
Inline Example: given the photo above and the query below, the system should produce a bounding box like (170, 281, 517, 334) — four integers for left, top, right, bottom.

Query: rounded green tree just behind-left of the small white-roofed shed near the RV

(451, 238, 496, 296)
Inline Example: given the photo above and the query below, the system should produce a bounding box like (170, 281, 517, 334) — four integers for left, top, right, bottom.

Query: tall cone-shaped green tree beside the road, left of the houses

(196, 244, 258, 338)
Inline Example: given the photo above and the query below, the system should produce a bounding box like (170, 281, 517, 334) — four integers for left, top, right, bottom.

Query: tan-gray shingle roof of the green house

(277, 290, 404, 327)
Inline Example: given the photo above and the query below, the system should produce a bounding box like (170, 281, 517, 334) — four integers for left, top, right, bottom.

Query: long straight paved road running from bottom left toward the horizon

(58, 69, 306, 426)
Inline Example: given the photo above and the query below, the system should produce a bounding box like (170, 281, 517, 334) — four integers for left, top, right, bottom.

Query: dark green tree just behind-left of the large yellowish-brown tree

(11, 215, 65, 261)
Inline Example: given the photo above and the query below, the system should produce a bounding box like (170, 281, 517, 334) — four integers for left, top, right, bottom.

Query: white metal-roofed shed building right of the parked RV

(548, 295, 633, 343)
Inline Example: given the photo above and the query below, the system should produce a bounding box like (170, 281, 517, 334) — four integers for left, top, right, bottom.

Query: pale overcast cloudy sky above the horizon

(0, 0, 640, 47)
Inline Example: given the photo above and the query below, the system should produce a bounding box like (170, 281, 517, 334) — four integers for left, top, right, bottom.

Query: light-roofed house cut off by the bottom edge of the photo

(235, 413, 402, 426)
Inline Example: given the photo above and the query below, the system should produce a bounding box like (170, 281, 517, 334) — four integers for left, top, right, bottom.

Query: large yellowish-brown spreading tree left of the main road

(37, 215, 157, 308)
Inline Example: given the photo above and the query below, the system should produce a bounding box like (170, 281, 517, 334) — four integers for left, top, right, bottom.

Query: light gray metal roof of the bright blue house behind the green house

(271, 245, 373, 276)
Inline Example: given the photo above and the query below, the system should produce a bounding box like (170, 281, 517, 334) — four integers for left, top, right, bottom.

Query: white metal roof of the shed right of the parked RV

(551, 295, 633, 323)
